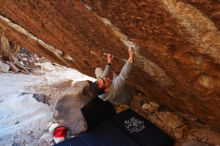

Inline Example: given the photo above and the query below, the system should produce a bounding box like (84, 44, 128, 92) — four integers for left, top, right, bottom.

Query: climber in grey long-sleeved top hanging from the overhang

(95, 47, 135, 104)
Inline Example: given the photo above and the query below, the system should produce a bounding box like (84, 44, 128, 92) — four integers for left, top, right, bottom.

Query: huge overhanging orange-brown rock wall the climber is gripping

(0, 0, 220, 127)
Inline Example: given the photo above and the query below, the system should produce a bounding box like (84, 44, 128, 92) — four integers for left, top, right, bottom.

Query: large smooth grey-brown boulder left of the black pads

(54, 81, 95, 134)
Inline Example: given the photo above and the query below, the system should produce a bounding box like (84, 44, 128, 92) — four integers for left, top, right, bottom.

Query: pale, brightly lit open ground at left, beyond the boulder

(0, 63, 94, 146)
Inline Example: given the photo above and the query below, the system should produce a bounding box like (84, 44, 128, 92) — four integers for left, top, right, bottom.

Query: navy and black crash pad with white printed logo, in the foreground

(56, 109, 174, 146)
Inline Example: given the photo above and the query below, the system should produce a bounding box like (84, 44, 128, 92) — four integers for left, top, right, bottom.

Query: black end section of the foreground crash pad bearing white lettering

(111, 109, 174, 146)
